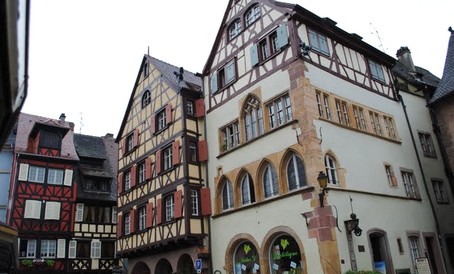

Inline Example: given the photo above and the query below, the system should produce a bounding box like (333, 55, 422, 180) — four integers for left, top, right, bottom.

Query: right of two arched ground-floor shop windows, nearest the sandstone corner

(269, 234, 303, 274)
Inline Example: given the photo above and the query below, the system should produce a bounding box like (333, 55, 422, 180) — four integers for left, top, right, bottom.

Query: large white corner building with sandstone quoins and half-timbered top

(202, 0, 446, 274)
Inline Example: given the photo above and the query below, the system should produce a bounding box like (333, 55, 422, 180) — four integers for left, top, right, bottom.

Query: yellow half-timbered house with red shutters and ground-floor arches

(117, 55, 211, 274)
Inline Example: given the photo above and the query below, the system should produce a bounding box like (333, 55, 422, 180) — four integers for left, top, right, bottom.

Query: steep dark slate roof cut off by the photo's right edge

(429, 28, 454, 104)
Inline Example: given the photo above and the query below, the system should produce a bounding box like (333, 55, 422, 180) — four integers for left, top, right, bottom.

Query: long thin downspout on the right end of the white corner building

(396, 87, 446, 270)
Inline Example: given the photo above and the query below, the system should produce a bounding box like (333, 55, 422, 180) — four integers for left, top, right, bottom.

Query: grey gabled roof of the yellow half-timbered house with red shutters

(116, 54, 203, 143)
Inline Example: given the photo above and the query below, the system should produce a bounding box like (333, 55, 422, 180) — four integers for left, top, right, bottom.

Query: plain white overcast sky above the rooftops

(22, 0, 454, 137)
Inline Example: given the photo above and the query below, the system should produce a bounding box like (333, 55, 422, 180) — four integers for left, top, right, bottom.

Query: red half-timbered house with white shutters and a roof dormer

(8, 113, 78, 273)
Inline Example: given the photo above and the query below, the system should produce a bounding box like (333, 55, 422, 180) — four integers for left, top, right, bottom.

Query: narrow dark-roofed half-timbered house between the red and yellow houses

(72, 134, 118, 273)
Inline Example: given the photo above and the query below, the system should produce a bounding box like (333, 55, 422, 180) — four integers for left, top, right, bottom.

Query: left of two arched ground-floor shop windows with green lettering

(233, 241, 260, 274)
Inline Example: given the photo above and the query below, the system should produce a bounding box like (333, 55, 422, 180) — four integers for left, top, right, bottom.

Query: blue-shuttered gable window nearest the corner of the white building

(251, 25, 288, 66)
